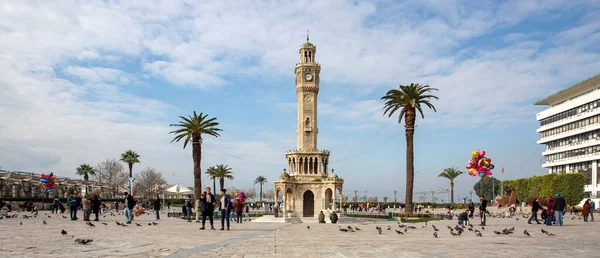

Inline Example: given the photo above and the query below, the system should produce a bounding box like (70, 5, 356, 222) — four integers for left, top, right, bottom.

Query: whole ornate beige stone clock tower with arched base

(274, 36, 344, 217)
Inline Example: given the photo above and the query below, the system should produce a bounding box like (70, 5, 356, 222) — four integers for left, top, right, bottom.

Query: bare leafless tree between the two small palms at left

(92, 159, 127, 197)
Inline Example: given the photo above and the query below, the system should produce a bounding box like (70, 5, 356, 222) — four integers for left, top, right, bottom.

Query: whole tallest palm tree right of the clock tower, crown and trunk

(381, 83, 438, 214)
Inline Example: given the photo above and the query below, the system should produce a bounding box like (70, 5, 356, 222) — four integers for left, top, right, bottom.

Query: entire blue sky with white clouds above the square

(0, 1, 600, 200)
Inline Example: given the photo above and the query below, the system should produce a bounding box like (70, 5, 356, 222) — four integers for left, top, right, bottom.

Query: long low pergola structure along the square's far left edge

(0, 170, 122, 198)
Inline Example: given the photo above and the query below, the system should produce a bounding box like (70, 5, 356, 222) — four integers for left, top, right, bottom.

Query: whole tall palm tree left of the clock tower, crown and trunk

(169, 111, 222, 220)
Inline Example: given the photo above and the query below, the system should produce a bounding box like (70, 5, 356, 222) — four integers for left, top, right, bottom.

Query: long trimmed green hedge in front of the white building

(504, 173, 585, 205)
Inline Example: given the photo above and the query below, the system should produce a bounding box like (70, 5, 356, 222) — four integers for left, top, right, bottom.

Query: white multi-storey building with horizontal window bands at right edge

(535, 74, 600, 198)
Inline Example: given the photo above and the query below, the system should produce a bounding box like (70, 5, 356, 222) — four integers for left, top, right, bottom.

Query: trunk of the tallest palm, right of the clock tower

(404, 108, 415, 214)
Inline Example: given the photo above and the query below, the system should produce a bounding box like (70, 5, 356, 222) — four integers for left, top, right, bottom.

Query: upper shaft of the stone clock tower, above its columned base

(294, 35, 321, 151)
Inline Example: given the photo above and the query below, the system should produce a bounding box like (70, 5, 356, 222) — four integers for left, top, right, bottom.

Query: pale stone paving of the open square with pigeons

(0, 212, 600, 258)
